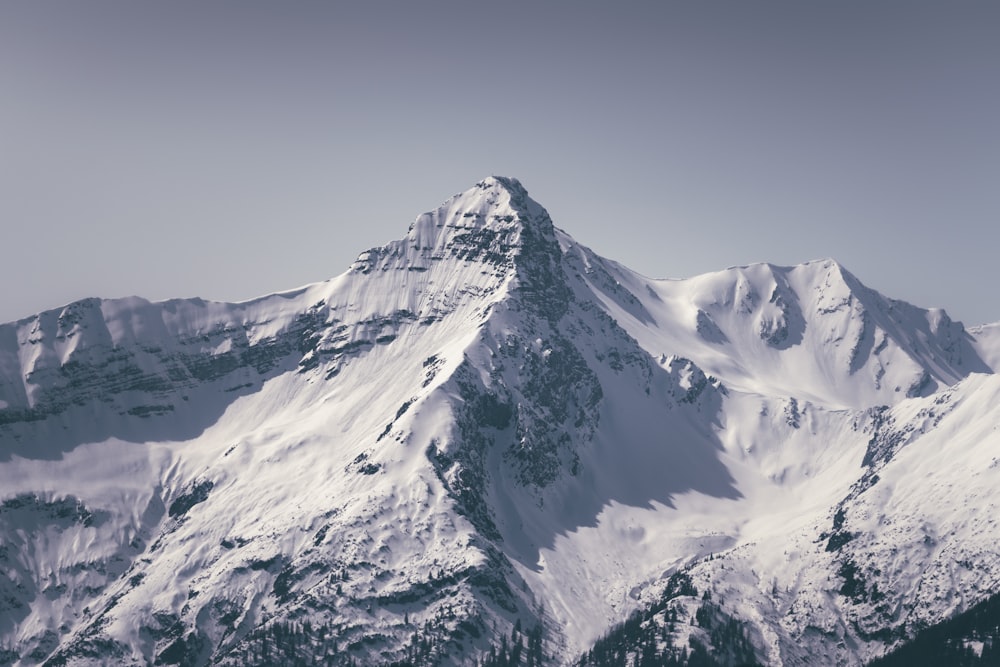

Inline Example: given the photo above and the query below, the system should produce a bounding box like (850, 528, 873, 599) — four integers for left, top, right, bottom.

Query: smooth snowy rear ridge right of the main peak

(563, 243, 992, 407)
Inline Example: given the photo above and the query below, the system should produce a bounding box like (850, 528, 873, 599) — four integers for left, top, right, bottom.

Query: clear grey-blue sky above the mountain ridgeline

(0, 0, 1000, 325)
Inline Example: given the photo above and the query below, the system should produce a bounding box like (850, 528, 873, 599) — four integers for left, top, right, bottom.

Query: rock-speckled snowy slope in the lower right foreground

(616, 376, 1000, 665)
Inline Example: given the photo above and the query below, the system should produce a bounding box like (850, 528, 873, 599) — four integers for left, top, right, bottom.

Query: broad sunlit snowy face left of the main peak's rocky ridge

(2, 179, 544, 663)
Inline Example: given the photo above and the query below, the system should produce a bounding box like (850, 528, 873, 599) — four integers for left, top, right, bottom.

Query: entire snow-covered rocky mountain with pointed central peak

(0, 177, 1000, 665)
